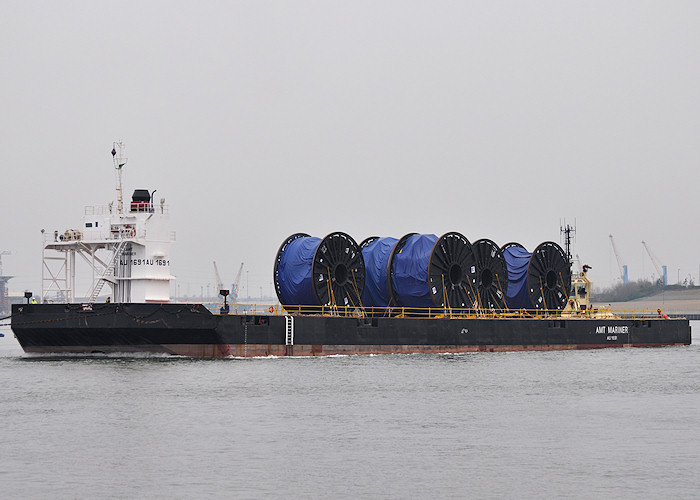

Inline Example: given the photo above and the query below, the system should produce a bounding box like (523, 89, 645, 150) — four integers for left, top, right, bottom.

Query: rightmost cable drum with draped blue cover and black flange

(501, 241, 571, 309)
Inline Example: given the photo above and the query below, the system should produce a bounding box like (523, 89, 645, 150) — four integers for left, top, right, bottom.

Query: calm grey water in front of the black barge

(0, 323, 700, 499)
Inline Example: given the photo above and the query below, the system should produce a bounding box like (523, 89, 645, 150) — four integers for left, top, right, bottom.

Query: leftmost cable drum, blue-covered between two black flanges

(274, 232, 365, 308)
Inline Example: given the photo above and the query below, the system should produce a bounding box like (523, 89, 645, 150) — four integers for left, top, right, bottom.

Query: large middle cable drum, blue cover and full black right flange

(388, 232, 477, 308)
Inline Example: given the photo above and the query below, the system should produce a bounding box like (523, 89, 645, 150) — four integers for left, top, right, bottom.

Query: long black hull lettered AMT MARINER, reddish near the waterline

(12, 304, 691, 357)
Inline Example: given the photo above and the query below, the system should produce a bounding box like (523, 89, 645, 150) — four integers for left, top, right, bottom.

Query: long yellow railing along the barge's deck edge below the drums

(205, 302, 680, 320)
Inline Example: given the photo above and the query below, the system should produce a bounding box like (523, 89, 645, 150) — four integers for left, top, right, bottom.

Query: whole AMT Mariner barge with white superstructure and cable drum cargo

(12, 143, 691, 357)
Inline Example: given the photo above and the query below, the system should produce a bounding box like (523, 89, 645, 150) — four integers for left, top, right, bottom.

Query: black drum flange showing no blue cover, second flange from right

(472, 238, 508, 309)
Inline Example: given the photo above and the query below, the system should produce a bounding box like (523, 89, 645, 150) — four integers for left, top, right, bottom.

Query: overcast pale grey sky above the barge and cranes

(0, 0, 700, 296)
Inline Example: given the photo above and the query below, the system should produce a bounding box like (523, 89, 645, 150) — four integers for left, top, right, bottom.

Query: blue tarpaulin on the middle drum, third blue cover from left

(391, 234, 438, 307)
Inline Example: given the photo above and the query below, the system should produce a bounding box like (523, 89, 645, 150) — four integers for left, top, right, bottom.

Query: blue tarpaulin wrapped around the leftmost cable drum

(277, 236, 321, 306)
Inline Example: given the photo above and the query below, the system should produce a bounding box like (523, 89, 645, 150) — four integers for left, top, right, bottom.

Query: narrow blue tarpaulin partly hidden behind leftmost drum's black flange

(362, 237, 399, 307)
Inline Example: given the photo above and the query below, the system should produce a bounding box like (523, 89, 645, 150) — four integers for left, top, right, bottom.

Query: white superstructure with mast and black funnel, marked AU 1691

(41, 143, 175, 304)
